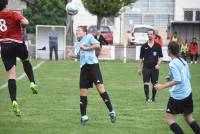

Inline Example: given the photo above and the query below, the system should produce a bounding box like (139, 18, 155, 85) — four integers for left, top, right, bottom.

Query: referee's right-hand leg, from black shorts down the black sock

(151, 69, 159, 102)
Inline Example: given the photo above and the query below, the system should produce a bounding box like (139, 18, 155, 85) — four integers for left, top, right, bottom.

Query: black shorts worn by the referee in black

(142, 68, 159, 84)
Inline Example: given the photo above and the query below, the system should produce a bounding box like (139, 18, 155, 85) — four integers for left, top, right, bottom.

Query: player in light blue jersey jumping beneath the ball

(68, 26, 116, 125)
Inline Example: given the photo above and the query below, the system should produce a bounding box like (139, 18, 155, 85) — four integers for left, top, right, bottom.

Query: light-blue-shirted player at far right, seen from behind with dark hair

(155, 42, 200, 134)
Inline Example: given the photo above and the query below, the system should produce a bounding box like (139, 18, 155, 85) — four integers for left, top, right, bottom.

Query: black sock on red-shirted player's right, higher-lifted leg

(22, 60, 35, 83)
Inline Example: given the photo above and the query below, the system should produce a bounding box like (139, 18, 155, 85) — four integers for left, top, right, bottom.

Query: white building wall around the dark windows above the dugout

(175, 0, 200, 21)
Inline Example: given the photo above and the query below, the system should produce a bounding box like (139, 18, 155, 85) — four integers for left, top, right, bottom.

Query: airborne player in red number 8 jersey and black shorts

(0, 0, 38, 116)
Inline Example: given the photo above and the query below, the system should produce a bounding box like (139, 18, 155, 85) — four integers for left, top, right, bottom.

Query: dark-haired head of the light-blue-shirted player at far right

(168, 42, 179, 57)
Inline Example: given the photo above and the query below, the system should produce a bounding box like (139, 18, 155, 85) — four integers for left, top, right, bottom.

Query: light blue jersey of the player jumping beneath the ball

(74, 34, 99, 67)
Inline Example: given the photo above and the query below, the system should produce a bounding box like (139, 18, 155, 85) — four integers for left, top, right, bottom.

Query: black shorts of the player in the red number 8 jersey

(1, 42, 28, 71)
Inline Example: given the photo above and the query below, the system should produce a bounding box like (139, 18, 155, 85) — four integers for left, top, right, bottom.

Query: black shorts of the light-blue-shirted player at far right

(166, 93, 193, 114)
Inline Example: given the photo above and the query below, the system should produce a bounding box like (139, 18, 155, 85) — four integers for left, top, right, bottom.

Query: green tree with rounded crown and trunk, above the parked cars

(82, 0, 136, 29)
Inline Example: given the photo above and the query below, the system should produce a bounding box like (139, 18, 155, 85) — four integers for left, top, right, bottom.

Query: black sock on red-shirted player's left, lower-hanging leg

(8, 79, 16, 101)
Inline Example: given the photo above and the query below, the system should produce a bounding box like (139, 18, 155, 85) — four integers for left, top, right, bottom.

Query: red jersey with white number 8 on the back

(0, 11, 24, 42)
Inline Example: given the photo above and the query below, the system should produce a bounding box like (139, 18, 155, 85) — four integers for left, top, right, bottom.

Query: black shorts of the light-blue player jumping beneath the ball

(80, 63, 103, 88)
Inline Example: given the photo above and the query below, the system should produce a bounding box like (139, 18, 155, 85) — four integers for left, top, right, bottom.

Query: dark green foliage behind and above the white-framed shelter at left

(24, 0, 66, 32)
